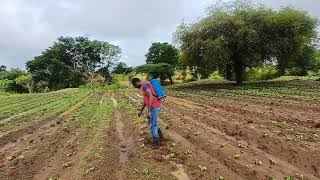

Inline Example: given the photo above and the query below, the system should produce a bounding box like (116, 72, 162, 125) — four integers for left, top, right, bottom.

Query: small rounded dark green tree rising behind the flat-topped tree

(145, 42, 178, 67)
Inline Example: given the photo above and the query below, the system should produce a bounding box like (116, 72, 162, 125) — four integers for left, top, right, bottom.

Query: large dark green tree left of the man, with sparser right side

(26, 37, 121, 90)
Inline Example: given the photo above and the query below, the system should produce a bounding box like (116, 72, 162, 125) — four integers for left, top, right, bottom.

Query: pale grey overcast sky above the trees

(0, 0, 320, 68)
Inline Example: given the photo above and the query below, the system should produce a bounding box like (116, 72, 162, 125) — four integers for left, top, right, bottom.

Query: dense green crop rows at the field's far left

(0, 89, 89, 132)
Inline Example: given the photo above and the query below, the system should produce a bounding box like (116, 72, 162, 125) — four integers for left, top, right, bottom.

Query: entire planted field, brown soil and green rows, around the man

(0, 81, 320, 180)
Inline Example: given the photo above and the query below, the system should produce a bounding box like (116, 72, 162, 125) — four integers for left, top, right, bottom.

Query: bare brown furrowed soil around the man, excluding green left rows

(0, 92, 320, 180)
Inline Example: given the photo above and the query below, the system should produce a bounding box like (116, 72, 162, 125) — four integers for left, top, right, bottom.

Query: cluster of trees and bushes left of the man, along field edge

(0, 37, 133, 93)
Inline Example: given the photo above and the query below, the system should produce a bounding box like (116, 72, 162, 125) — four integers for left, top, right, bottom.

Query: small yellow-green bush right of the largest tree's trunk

(246, 66, 279, 81)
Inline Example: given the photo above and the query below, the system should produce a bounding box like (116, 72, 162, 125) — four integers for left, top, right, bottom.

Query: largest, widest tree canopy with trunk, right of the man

(176, 1, 317, 84)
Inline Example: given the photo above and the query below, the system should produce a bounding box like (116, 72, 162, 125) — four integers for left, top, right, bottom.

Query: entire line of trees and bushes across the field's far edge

(0, 0, 320, 93)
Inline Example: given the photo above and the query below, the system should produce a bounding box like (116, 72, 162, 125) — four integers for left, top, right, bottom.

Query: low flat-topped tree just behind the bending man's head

(134, 63, 174, 84)
